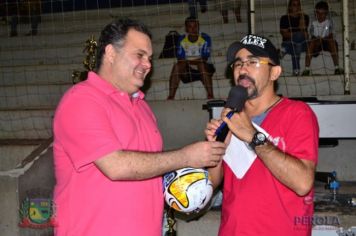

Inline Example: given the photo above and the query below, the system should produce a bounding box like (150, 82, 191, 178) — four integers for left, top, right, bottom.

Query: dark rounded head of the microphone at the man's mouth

(225, 85, 248, 112)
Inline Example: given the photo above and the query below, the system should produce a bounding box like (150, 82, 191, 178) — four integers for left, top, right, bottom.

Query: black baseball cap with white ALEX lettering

(227, 34, 280, 65)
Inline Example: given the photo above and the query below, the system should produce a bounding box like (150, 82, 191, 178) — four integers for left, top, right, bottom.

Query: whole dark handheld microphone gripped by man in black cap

(215, 85, 247, 142)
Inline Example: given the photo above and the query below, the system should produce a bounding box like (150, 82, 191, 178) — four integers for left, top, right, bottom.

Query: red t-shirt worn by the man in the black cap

(219, 98, 319, 236)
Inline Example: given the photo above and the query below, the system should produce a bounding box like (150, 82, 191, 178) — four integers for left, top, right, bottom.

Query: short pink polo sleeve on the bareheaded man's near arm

(54, 88, 122, 171)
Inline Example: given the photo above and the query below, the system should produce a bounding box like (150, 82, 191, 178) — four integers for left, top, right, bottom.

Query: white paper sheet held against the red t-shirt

(224, 123, 269, 179)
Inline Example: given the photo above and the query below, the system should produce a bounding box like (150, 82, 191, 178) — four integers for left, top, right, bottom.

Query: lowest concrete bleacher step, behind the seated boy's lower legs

(0, 65, 352, 111)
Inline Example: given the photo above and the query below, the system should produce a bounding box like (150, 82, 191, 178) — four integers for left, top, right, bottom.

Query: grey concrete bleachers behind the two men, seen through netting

(0, 0, 356, 121)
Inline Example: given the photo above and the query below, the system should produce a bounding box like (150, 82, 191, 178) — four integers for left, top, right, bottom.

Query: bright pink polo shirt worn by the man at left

(54, 72, 163, 236)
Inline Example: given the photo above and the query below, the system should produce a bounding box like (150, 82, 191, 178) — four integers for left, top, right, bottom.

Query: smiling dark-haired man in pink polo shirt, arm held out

(54, 19, 225, 236)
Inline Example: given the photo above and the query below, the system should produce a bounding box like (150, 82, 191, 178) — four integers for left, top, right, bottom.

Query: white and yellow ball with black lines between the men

(163, 168, 213, 213)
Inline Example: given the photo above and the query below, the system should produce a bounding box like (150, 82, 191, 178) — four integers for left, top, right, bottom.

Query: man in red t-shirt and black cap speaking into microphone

(205, 35, 319, 236)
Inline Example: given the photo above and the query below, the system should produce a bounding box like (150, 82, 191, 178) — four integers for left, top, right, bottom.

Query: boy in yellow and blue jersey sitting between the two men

(167, 17, 215, 100)
